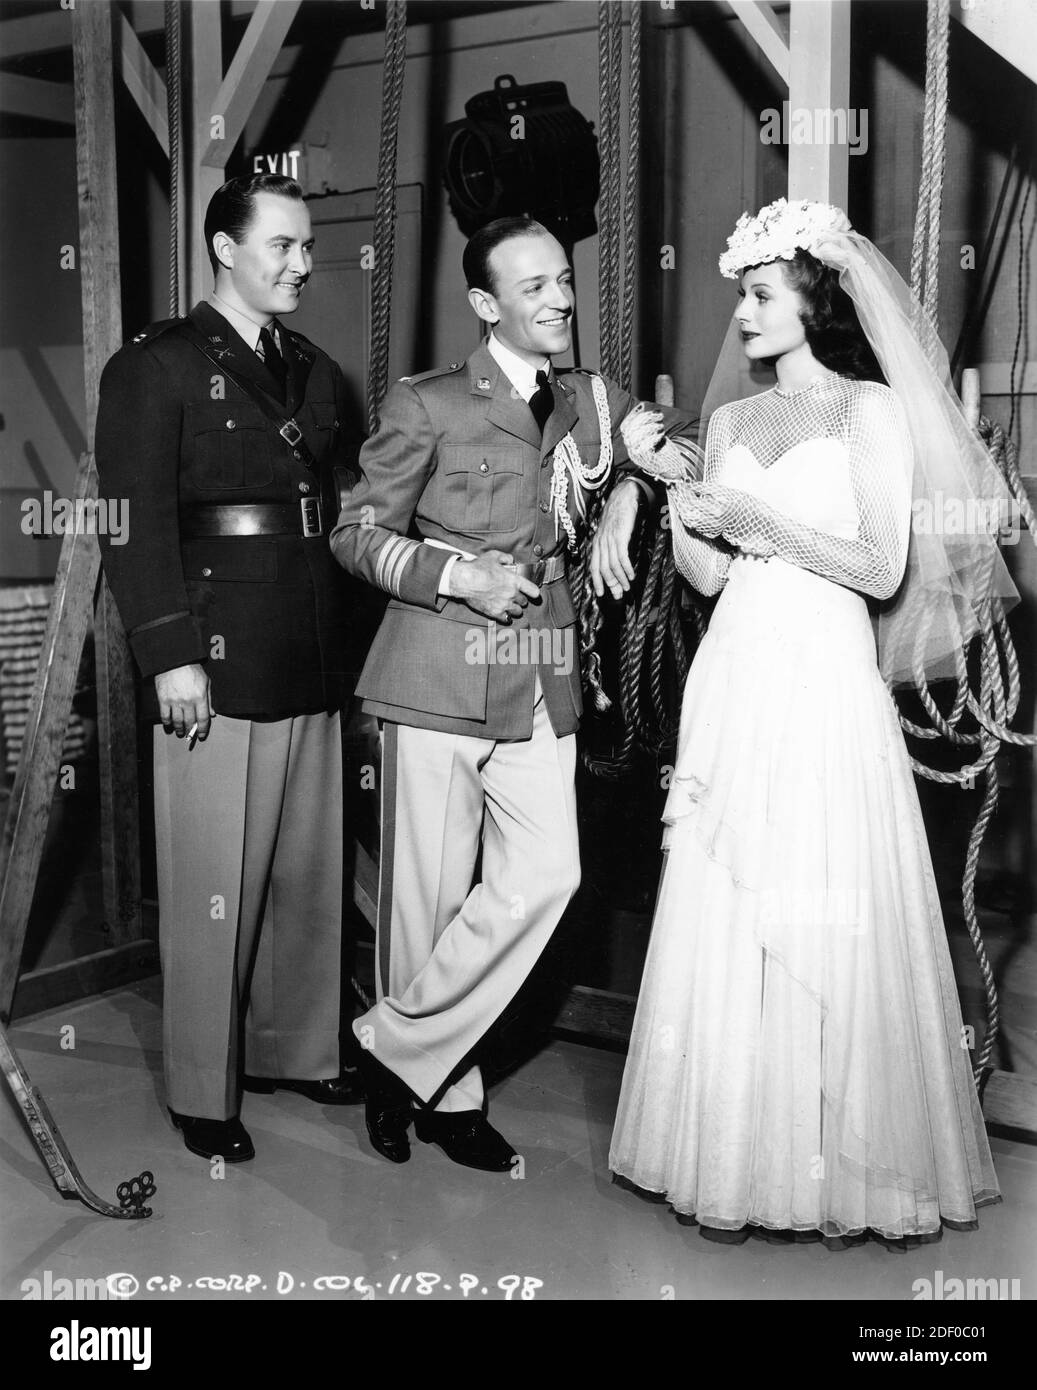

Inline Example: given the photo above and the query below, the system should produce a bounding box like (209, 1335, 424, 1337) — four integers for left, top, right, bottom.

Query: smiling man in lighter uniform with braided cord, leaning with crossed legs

(331, 218, 691, 1170)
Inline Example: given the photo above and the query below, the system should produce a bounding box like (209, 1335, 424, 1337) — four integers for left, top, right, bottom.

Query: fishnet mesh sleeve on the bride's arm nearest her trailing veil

(689, 384, 912, 599)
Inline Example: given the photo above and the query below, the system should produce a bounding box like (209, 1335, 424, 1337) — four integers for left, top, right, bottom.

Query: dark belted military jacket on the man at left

(96, 303, 370, 720)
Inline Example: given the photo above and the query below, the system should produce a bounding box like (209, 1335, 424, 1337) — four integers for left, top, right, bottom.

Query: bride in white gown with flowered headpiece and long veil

(609, 199, 1013, 1243)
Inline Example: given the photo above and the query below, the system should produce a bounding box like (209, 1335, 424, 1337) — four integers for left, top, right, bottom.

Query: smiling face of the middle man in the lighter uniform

(473, 232, 575, 367)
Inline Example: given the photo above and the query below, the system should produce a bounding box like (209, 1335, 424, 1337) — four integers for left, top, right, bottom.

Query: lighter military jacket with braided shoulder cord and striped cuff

(331, 345, 692, 739)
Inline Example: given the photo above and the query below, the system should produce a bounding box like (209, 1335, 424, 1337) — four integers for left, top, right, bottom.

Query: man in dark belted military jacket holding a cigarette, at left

(96, 175, 363, 1161)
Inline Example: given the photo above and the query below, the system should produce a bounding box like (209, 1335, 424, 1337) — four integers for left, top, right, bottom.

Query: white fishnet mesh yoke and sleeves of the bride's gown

(670, 375, 912, 599)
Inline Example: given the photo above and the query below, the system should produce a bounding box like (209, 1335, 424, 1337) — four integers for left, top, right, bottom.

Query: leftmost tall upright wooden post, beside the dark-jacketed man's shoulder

(72, 4, 142, 945)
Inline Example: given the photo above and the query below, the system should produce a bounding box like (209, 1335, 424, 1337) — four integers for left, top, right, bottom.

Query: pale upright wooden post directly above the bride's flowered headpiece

(788, 0, 849, 209)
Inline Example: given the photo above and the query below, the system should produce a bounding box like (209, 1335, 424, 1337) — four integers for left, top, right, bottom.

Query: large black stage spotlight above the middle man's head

(443, 74, 601, 246)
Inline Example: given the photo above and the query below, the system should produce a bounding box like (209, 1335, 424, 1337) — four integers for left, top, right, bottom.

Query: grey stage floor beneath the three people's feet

(0, 979, 1037, 1301)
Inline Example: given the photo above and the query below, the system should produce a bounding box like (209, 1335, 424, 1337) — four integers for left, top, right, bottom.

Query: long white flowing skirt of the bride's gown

(610, 559, 998, 1238)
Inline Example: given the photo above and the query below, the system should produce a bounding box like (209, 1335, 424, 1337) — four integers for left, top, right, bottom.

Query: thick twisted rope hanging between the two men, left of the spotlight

(367, 0, 407, 434)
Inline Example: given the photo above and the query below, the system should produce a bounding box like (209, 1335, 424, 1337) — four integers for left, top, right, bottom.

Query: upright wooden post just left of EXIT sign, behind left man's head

(181, 4, 223, 309)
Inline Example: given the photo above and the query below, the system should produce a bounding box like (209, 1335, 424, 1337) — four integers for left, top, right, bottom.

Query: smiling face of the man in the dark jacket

(214, 193, 313, 322)
